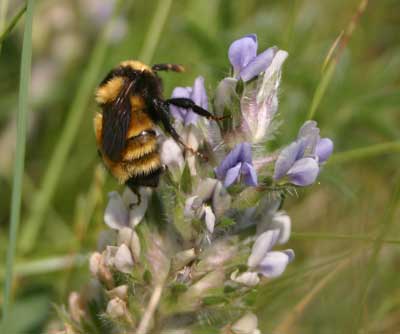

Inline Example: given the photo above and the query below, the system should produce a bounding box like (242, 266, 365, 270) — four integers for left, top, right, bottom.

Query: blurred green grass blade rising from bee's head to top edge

(139, 0, 172, 63)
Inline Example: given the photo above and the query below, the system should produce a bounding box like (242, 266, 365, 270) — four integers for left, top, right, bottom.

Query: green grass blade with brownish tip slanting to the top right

(307, 0, 368, 119)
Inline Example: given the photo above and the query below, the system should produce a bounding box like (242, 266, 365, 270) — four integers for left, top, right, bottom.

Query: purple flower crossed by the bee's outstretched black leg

(170, 76, 208, 125)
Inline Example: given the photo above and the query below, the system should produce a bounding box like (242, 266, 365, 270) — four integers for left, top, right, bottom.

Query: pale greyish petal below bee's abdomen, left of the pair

(104, 191, 129, 230)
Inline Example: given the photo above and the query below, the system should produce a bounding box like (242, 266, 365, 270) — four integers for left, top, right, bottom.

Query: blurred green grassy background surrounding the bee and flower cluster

(0, 0, 400, 334)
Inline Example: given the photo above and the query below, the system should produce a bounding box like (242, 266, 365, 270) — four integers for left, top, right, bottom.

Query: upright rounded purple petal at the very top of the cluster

(228, 34, 258, 76)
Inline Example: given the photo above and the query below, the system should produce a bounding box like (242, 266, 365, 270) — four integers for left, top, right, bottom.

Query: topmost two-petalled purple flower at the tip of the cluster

(228, 34, 277, 82)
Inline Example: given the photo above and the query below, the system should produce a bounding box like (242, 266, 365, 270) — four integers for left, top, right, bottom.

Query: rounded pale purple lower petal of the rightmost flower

(287, 158, 319, 187)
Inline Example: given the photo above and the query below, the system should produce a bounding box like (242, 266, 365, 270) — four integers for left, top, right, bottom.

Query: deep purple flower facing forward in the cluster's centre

(215, 143, 257, 188)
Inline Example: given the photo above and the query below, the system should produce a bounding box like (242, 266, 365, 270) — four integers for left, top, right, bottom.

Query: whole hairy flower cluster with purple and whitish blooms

(57, 35, 333, 334)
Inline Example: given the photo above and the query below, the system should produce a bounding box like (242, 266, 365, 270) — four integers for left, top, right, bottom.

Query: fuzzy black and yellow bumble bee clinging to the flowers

(94, 60, 220, 193)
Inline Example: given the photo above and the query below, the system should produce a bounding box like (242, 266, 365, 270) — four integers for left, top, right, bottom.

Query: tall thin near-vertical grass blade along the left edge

(3, 0, 35, 320)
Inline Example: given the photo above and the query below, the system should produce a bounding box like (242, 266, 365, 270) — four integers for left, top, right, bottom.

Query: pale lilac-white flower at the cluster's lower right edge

(247, 230, 294, 278)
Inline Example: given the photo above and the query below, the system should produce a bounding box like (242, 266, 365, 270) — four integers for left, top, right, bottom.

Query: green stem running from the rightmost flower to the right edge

(328, 141, 400, 164)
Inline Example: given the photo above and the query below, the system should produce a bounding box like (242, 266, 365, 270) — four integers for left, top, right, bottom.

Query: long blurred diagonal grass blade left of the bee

(20, 1, 121, 253)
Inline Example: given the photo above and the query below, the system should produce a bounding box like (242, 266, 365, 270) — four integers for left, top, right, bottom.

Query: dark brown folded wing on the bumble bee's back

(102, 82, 133, 161)
